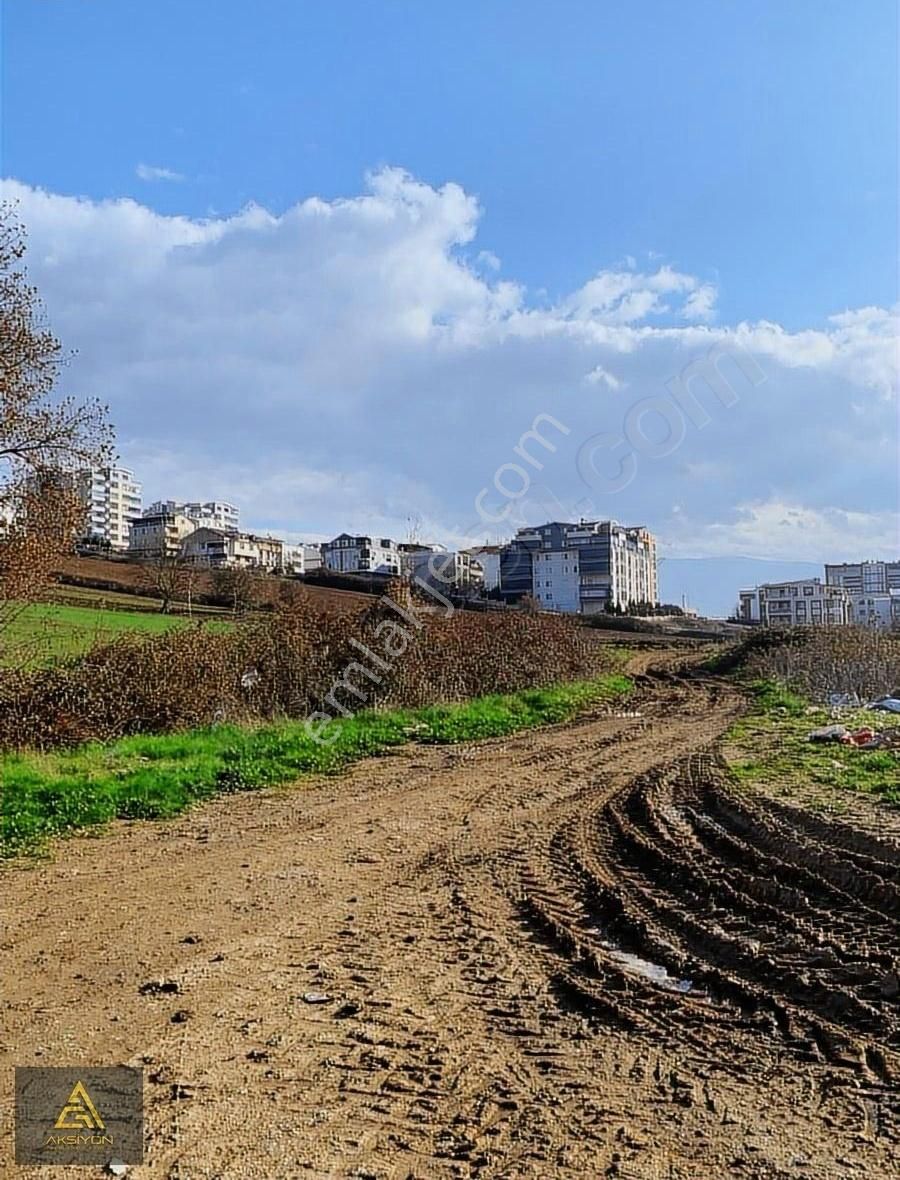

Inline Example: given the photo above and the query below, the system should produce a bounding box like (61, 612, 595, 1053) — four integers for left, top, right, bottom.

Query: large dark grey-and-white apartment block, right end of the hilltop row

(500, 520, 659, 615)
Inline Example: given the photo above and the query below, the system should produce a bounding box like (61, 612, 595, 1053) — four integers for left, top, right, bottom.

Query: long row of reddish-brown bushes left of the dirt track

(0, 586, 609, 750)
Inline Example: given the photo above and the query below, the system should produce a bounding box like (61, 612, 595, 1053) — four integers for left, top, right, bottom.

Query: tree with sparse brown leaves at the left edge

(0, 204, 113, 628)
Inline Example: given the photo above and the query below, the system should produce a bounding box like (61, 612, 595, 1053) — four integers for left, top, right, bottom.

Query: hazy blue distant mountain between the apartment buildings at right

(659, 557, 825, 618)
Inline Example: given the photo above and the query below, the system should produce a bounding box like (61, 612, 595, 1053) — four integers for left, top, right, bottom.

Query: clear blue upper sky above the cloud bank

(2, 0, 898, 328)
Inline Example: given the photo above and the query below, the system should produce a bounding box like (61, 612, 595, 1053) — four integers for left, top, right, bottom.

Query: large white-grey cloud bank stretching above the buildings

(5, 169, 898, 559)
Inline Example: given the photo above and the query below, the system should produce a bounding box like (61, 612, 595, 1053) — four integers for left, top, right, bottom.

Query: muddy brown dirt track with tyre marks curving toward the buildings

(0, 660, 900, 1180)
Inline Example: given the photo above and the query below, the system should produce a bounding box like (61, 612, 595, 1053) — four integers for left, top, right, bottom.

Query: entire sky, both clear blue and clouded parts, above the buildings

(0, 0, 900, 608)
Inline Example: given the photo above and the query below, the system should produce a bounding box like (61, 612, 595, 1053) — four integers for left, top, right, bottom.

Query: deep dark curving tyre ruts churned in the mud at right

(520, 736, 900, 1140)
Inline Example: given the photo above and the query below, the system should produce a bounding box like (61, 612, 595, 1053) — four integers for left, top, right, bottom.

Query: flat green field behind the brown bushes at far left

(0, 603, 232, 667)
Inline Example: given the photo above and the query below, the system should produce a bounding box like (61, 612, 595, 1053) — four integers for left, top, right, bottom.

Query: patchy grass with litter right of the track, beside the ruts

(725, 681, 900, 805)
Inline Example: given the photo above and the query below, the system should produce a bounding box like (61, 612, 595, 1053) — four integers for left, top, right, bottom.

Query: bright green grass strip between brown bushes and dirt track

(0, 673, 633, 857)
